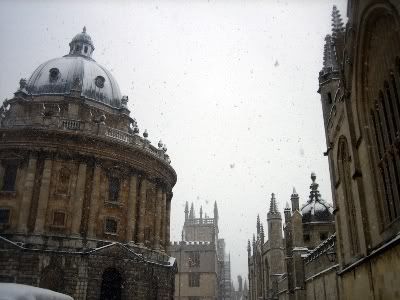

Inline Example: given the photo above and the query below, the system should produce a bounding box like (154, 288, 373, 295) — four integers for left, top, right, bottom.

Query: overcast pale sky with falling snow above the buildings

(0, 0, 346, 286)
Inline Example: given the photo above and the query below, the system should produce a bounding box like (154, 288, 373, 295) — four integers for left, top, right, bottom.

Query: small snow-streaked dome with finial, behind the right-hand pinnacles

(301, 173, 333, 223)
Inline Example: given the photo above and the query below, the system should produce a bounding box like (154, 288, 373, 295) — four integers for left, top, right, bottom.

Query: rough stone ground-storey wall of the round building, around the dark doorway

(0, 238, 176, 300)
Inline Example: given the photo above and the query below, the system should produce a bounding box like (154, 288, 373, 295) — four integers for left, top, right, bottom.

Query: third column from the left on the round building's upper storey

(71, 163, 86, 235)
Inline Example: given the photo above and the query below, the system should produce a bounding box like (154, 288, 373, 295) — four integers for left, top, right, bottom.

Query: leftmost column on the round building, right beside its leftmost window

(17, 154, 37, 233)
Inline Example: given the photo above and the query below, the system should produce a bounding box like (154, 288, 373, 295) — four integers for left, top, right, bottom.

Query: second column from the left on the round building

(35, 158, 53, 233)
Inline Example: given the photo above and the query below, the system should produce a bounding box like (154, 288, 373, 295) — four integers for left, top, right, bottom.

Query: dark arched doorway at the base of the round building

(100, 268, 122, 300)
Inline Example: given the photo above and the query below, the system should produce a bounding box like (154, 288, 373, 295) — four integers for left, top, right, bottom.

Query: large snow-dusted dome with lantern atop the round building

(25, 28, 121, 108)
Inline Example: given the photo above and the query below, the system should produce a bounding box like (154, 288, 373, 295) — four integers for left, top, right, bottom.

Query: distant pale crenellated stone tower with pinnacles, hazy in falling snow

(169, 202, 231, 300)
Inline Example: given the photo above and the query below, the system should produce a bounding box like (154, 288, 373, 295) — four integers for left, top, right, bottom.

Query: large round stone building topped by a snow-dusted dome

(0, 28, 176, 299)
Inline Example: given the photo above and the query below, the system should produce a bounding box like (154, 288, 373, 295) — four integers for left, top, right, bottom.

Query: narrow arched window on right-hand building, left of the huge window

(337, 136, 360, 256)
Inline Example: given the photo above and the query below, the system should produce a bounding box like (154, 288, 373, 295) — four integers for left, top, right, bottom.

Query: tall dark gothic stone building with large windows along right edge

(319, 0, 400, 299)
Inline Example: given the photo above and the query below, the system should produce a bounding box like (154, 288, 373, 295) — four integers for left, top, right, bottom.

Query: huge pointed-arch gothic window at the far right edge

(360, 8, 400, 230)
